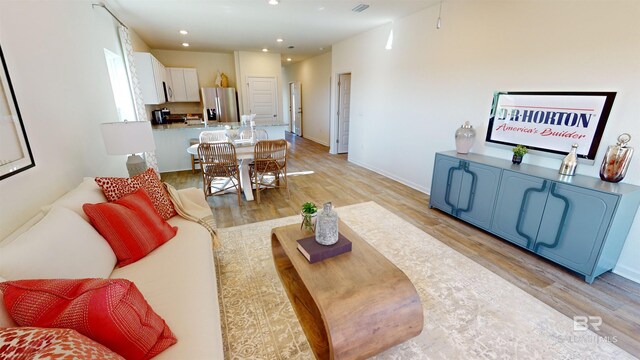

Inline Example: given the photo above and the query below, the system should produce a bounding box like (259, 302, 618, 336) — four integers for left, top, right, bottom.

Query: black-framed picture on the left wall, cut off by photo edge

(0, 47, 35, 180)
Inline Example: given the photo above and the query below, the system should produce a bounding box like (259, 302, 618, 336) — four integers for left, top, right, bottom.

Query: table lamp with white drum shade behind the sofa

(100, 121, 156, 177)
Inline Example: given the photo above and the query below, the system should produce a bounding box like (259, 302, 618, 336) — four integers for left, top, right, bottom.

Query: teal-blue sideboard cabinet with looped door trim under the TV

(429, 151, 640, 283)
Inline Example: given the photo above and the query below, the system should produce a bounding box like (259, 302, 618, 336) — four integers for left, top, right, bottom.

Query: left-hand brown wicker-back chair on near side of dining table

(198, 142, 242, 205)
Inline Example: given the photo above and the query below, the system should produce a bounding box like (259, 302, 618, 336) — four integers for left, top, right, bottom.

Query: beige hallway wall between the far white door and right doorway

(283, 52, 331, 146)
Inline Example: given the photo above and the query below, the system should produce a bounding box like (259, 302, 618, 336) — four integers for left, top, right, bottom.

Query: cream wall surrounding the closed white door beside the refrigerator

(233, 51, 284, 122)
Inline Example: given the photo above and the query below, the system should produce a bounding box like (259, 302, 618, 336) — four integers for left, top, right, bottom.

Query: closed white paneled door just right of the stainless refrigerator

(247, 76, 278, 122)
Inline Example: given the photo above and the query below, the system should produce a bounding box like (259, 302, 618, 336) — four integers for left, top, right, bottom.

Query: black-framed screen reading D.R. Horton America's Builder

(486, 91, 616, 160)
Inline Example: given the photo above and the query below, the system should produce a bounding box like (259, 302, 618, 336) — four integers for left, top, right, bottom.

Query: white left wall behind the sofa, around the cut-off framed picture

(0, 1, 126, 238)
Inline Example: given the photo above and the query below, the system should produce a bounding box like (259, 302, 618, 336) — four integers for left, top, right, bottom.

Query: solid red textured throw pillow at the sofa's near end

(0, 279, 177, 360)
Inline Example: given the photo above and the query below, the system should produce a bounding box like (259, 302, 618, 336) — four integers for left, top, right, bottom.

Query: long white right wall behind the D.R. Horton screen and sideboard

(331, 0, 640, 282)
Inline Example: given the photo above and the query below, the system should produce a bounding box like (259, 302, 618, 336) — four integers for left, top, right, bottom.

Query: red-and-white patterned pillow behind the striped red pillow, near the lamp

(96, 168, 177, 220)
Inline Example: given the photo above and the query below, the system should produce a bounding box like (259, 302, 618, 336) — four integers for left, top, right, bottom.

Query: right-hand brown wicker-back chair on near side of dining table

(249, 140, 290, 203)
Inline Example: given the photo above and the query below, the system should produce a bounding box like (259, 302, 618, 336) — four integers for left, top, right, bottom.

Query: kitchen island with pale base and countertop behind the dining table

(152, 121, 289, 172)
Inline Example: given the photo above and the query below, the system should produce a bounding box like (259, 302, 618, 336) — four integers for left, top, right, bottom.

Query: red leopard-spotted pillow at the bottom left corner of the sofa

(0, 327, 124, 360)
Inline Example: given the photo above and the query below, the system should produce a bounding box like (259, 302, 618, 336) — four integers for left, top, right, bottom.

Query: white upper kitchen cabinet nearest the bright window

(133, 52, 167, 105)
